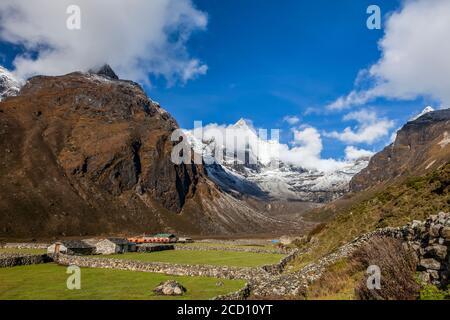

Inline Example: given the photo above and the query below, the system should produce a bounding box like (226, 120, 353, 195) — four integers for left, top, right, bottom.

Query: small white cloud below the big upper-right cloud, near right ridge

(325, 109, 394, 144)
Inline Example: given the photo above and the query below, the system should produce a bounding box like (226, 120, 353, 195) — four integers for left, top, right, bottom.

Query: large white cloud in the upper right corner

(327, 0, 450, 110)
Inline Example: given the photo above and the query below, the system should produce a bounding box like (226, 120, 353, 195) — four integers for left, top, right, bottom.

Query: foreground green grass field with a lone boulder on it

(0, 264, 245, 300)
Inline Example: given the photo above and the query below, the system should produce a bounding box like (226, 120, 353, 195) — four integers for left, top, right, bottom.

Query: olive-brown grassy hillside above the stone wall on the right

(295, 163, 450, 268)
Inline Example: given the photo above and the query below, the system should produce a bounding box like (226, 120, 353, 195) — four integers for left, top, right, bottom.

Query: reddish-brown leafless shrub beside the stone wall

(353, 237, 420, 300)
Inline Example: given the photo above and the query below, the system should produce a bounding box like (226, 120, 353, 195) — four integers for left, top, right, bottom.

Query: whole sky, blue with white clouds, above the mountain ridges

(0, 0, 444, 159)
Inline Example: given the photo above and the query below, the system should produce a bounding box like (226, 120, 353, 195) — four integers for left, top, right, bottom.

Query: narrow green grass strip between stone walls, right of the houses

(101, 250, 284, 267)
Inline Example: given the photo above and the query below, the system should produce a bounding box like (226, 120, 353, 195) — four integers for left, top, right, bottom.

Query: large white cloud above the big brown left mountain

(0, 0, 207, 83)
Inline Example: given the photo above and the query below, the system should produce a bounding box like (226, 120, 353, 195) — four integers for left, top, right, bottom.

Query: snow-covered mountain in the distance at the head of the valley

(185, 120, 369, 203)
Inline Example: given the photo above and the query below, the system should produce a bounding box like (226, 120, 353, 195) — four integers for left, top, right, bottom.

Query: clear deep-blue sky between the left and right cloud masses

(147, 0, 426, 157)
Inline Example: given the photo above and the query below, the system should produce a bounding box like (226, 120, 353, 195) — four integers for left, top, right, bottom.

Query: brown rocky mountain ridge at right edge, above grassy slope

(350, 109, 450, 191)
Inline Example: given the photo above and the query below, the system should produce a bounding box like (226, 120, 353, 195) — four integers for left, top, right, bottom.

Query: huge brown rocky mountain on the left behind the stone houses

(0, 68, 301, 238)
